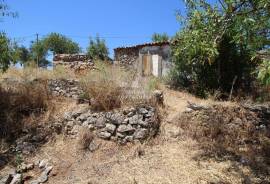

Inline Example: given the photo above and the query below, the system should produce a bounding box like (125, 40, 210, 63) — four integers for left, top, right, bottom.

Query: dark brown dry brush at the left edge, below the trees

(0, 83, 50, 140)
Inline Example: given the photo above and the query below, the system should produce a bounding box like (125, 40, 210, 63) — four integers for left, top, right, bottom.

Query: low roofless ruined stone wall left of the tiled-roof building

(53, 54, 94, 71)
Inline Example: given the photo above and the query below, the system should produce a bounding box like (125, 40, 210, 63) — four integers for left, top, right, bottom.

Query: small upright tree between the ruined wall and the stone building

(87, 36, 109, 60)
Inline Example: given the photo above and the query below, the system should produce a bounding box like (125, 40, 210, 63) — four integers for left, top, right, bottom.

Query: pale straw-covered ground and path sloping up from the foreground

(1, 88, 267, 184)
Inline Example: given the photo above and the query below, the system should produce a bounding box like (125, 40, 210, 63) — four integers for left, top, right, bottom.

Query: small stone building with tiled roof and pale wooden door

(114, 42, 172, 77)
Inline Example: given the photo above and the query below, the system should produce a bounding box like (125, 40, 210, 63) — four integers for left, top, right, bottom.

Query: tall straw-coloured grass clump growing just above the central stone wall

(81, 62, 154, 111)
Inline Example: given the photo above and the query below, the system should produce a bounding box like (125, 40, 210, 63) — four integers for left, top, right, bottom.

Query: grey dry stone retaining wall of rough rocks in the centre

(62, 106, 159, 144)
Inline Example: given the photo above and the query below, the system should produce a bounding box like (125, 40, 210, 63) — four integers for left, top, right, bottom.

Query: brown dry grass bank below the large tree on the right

(178, 105, 270, 182)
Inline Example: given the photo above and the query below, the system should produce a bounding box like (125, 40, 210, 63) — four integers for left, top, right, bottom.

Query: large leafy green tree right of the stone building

(170, 0, 270, 96)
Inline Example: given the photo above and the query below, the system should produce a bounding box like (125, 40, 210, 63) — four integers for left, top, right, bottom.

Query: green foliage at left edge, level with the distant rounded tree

(0, 33, 15, 71)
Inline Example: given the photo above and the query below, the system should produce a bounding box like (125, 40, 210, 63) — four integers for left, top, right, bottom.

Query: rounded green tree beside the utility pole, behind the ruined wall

(42, 33, 80, 54)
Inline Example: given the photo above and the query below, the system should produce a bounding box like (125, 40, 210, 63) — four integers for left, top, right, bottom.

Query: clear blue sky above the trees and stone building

(0, 0, 184, 56)
